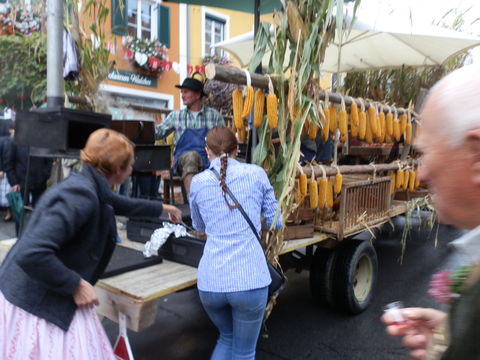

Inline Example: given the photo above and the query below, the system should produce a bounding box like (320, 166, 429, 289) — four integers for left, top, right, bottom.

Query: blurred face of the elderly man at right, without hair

(415, 99, 480, 229)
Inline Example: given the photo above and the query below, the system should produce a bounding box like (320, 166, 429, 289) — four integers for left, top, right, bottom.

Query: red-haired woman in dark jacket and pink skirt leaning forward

(0, 129, 181, 360)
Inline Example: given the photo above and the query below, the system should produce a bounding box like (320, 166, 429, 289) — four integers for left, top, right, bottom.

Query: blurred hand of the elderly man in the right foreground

(381, 308, 447, 359)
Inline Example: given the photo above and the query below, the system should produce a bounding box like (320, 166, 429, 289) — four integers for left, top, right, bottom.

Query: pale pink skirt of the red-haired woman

(0, 291, 115, 360)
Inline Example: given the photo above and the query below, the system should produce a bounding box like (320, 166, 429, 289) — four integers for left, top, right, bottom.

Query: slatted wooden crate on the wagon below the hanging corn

(315, 176, 392, 241)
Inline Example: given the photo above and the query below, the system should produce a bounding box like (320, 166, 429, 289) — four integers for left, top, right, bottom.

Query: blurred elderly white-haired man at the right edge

(382, 65, 480, 360)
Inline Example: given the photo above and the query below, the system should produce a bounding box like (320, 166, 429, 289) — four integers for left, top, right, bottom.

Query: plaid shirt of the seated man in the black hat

(155, 106, 225, 144)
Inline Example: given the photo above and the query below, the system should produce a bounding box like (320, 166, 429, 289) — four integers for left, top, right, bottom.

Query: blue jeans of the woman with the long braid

(199, 287, 268, 360)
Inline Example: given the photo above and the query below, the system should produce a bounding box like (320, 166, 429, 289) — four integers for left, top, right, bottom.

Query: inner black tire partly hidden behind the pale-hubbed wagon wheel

(310, 247, 337, 306)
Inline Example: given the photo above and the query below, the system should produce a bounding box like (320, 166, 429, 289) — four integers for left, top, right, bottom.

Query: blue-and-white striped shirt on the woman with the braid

(190, 158, 282, 292)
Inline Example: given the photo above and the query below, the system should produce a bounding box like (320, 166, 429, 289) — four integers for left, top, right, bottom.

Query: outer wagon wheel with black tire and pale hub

(333, 239, 378, 314)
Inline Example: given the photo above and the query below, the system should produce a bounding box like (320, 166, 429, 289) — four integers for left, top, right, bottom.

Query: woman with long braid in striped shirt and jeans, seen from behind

(190, 126, 282, 360)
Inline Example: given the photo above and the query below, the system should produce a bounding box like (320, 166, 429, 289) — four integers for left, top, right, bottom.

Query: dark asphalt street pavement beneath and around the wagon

(0, 211, 462, 360)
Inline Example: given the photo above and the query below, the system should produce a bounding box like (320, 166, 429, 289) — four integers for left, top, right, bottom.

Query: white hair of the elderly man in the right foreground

(426, 65, 480, 147)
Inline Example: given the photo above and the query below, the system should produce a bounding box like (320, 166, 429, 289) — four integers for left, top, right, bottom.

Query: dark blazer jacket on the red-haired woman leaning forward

(0, 165, 162, 331)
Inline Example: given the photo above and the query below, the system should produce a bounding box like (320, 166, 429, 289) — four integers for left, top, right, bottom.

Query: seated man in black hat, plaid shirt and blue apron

(155, 74, 225, 195)
